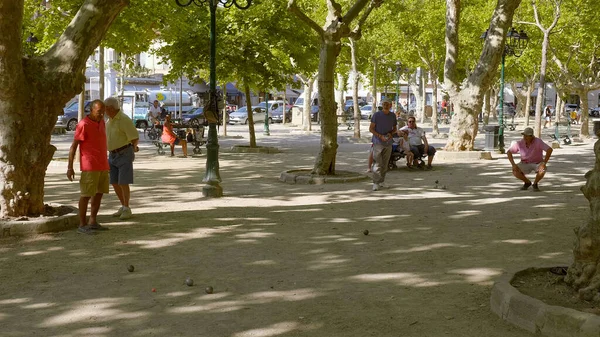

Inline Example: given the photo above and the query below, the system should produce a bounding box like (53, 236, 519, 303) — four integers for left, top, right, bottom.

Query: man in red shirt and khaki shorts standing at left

(67, 100, 110, 234)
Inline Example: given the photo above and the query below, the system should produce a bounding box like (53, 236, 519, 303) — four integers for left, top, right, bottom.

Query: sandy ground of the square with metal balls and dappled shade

(0, 121, 593, 337)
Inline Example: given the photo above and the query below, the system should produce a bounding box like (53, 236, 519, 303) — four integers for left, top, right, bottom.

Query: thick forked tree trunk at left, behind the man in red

(0, 0, 126, 218)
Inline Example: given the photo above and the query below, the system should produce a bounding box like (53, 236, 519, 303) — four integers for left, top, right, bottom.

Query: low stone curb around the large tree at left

(0, 206, 79, 238)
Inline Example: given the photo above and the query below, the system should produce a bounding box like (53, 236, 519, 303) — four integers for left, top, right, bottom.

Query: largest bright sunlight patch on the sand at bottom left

(38, 298, 149, 328)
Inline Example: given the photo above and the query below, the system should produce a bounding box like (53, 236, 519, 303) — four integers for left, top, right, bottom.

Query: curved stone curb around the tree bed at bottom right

(490, 267, 600, 337)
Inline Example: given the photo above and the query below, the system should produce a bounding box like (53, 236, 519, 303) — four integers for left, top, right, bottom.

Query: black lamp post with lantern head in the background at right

(481, 27, 529, 153)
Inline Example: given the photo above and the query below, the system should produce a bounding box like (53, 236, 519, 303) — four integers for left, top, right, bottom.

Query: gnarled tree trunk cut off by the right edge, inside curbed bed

(565, 140, 600, 302)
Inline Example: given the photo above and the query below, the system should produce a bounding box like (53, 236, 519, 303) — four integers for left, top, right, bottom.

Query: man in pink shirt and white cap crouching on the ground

(506, 128, 552, 192)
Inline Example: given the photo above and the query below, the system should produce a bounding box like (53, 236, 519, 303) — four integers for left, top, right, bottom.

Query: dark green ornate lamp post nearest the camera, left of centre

(175, 0, 252, 198)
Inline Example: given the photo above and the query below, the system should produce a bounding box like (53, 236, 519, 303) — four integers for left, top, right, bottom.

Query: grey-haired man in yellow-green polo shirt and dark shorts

(104, 97, 139, 220)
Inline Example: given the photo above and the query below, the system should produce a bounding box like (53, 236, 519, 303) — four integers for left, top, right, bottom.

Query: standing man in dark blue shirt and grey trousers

(369, 99, 397, 191)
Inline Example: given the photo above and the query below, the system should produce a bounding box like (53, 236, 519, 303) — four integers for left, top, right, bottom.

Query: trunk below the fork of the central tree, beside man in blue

(312, 40, 340, 175)
